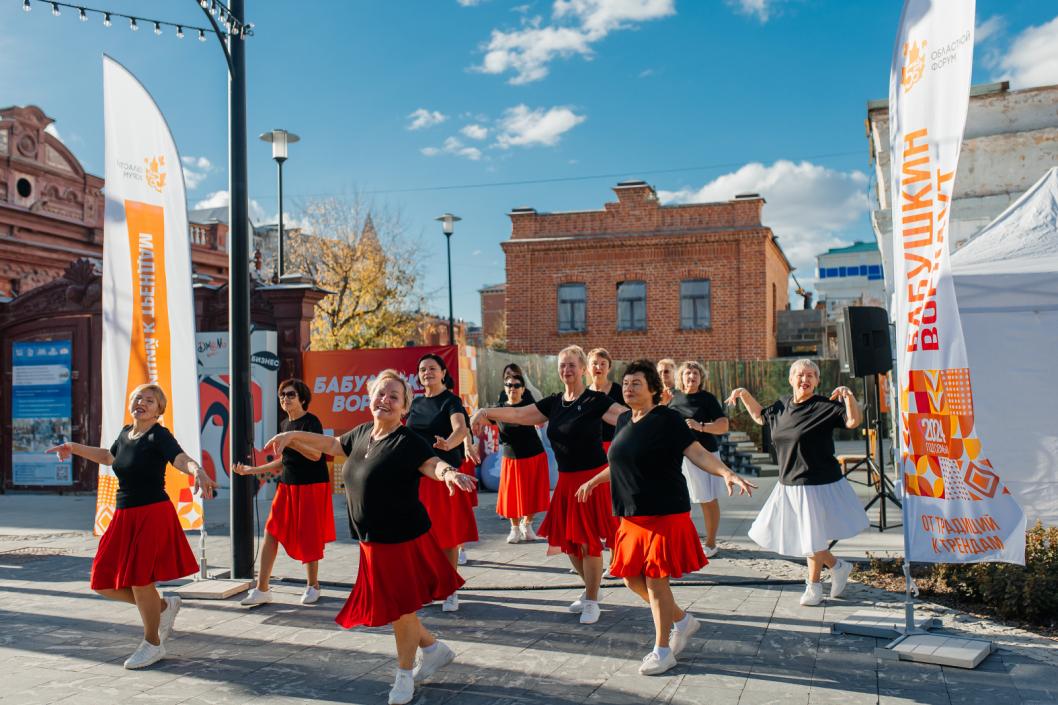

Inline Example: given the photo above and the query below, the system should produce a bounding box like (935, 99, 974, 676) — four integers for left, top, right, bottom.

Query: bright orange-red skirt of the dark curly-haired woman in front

(609, 512, 709, 578)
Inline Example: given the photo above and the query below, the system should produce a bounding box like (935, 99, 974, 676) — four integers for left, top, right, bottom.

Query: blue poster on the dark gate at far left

(11, 340, 73, 486)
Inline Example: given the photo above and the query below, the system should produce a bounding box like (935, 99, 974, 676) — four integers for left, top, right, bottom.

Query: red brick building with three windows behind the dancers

(499, 181, 791, 360)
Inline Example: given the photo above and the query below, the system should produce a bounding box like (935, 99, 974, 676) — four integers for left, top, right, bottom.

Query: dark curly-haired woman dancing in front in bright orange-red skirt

(577, 360, 754, 675)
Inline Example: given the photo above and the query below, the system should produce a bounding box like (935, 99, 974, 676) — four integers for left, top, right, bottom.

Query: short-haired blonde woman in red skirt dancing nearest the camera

(269, 369, 475, 705)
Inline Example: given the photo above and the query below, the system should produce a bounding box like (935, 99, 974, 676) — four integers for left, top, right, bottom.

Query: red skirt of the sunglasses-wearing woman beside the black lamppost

(265, 483, 338, 563)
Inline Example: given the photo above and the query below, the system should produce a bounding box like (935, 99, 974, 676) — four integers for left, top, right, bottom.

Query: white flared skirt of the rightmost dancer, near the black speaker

(749, 478, 870, 556)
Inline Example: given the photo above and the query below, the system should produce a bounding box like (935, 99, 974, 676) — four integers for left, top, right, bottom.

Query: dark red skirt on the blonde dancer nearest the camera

(334, 531, 463, 629)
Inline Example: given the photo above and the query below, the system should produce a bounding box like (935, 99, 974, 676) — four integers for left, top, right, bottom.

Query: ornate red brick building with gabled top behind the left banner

(0, 106, 227, 296)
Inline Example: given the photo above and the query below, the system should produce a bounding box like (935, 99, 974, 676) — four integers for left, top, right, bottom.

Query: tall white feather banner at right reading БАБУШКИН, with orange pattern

(889, 0, 1025, 564)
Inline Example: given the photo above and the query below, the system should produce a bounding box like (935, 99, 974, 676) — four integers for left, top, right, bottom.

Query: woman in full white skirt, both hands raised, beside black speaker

(727, 360, 869, 604)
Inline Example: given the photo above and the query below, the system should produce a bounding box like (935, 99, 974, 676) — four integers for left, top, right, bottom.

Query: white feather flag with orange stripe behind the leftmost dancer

(94, 56, 202, 534)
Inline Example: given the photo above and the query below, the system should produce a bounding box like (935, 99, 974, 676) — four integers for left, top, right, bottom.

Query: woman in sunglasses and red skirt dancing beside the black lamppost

(233, 379, 336, 605)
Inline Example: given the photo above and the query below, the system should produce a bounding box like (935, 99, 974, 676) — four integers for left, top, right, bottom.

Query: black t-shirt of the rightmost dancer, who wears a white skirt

(761, 394, 847, 485)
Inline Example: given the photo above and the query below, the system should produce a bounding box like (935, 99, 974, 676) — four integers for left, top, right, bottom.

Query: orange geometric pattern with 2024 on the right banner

(900, 367, 1007, 501)
